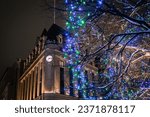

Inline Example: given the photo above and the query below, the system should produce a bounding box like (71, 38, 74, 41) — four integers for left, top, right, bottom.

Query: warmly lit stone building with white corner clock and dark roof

(17, 24, 97, 100)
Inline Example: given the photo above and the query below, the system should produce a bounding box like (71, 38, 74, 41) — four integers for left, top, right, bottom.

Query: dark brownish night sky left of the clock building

(0, 0, 63, 74)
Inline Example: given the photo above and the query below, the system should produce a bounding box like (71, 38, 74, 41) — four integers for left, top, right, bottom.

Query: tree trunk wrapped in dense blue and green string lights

(63, 0, 102, 99)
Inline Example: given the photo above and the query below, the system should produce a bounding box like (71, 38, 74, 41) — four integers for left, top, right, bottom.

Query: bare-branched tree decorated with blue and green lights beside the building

(44, 0, 150, 99)
